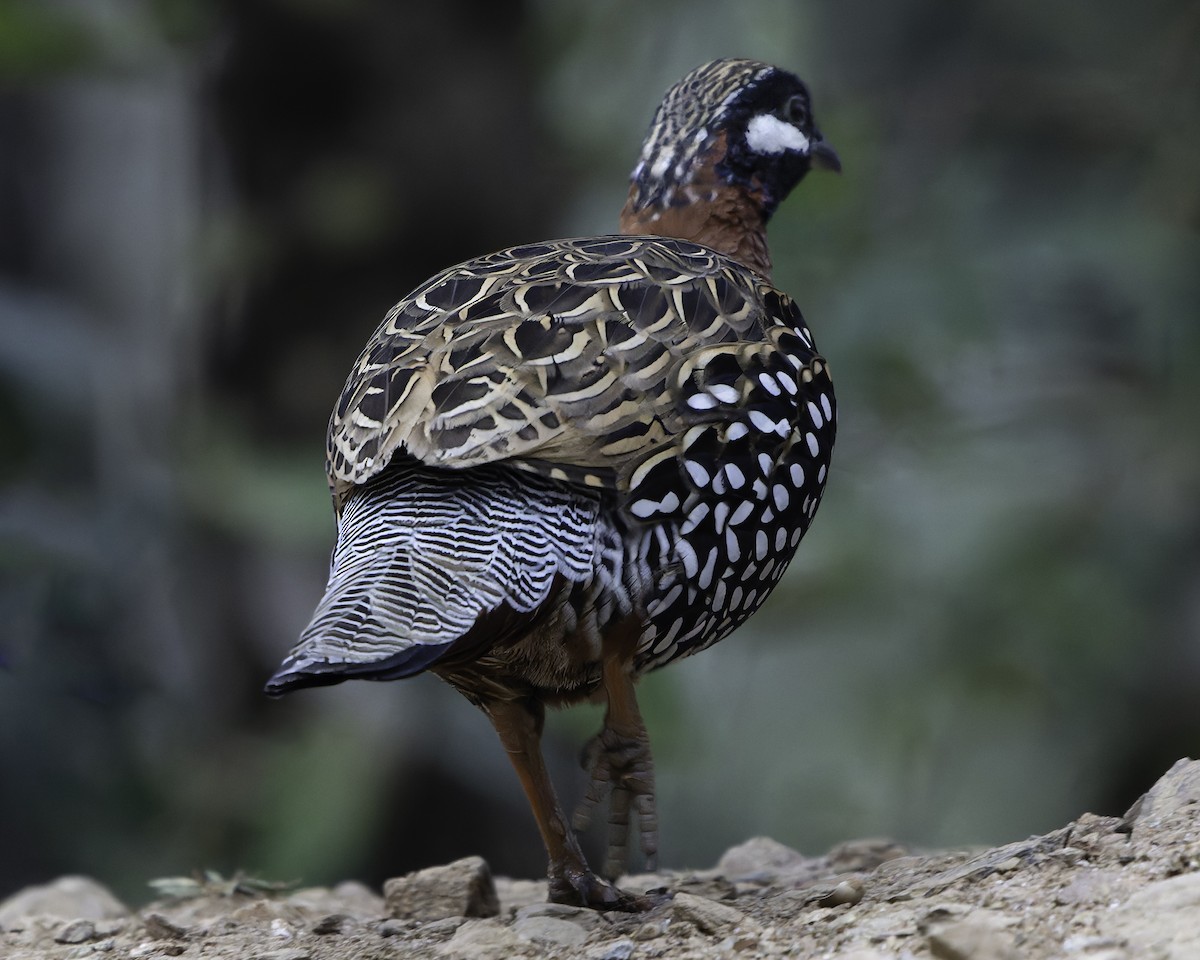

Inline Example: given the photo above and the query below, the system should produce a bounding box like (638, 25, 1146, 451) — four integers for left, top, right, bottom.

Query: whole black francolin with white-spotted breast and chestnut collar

(266, 59, 841, 911)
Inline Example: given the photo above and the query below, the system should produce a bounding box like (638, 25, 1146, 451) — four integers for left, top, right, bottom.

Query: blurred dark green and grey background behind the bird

(0, 0, 1200, 900)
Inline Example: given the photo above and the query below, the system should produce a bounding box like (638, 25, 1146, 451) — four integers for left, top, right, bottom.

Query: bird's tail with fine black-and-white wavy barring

(266, 463, 599, 696)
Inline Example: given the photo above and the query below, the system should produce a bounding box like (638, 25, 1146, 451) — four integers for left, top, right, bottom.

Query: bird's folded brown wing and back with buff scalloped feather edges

(326, 236, 798, 509)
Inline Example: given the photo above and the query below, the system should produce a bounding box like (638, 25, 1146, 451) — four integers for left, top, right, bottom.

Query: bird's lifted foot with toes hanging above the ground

(572, 725, 659, 883)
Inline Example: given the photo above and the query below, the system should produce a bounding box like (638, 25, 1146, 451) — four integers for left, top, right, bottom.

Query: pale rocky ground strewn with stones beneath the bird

(0, 761, 1200, 960)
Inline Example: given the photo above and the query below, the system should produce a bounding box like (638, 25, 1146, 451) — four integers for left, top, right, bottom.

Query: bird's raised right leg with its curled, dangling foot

(574, 655, 659, 880)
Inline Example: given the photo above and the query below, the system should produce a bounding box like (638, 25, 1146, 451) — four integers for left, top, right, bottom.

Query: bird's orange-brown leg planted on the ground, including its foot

(482, 700, 658, 912)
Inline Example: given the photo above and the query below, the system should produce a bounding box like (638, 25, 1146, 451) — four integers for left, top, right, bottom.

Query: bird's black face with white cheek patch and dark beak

(716, 70, 841, 217)
